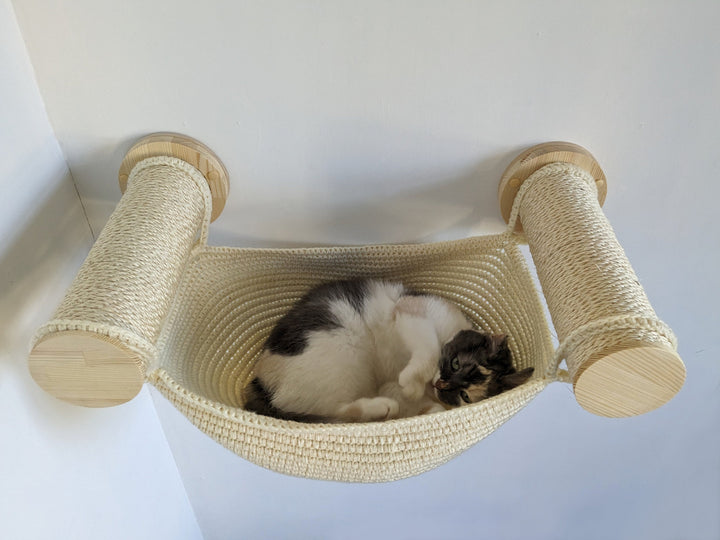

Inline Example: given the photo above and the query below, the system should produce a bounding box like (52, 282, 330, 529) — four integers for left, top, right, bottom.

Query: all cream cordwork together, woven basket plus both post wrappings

(35, 157, 674, 482)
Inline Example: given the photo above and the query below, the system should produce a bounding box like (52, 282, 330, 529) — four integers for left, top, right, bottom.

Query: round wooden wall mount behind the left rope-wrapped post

(118, 133, 230, 221)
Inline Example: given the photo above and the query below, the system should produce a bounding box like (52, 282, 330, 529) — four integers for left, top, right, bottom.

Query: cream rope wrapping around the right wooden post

(510, 163, 677, 379)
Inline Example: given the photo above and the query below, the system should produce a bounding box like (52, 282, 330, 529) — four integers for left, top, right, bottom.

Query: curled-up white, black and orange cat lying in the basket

(244, 279, 533, 422)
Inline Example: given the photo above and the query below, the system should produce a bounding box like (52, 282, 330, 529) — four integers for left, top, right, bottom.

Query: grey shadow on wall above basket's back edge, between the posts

(210, 141, 519, 248)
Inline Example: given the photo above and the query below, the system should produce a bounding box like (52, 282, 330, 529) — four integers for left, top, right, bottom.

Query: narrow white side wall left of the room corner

(0, 0, 202, 540)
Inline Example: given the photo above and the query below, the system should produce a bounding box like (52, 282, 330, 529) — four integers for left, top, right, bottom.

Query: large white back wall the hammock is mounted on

(15, 0, 720, 540)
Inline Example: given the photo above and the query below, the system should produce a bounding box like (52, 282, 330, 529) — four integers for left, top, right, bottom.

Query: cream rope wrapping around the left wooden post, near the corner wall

(34, 157, 210, 367)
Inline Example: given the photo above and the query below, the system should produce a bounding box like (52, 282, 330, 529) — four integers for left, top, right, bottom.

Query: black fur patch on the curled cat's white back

(265, 279, 368, 356)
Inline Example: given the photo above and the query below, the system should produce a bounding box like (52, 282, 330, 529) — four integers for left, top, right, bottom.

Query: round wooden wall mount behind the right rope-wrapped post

(498, 141, 607, 232)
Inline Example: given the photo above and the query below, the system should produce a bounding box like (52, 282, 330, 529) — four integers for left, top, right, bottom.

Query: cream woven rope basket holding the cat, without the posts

(151, 235, 552, 482)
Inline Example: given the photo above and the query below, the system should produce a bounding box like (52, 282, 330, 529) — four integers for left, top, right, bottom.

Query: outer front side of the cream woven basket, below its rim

(150, 370, 549, 482)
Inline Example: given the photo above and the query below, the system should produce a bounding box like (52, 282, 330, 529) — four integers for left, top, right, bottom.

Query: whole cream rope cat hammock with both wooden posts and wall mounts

(29, 134, 685, 482)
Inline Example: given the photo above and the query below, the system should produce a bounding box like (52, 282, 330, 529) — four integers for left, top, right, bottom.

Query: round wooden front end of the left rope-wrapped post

(28, 331, 145, 407)
